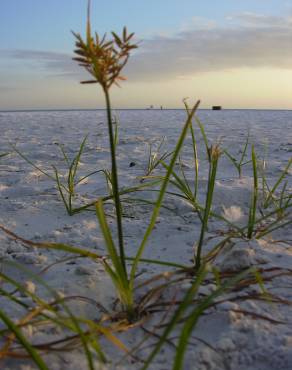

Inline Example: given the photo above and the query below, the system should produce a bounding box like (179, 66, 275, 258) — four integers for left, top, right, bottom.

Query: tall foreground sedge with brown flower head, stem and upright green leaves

(73, 1, 200, 320)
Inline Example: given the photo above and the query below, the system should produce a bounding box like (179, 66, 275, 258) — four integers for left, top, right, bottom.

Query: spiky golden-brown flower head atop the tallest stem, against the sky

(73, 1, 137, 90)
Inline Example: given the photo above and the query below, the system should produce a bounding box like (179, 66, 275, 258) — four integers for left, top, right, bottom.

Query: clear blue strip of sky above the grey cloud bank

(0, 0, 292, 51)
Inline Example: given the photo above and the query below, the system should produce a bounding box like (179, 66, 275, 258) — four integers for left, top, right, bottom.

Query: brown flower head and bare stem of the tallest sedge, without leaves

(73, 1, 137, 284)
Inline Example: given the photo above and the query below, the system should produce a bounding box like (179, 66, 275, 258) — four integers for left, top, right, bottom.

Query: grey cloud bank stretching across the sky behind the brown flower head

(0, 13, 292, 81)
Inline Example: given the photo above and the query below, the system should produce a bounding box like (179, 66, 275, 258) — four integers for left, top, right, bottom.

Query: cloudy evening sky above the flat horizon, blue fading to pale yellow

(0, 0, 292, 110)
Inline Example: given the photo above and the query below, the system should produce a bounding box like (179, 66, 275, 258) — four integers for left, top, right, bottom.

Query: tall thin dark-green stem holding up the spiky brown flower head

(103, 88, 127, 276)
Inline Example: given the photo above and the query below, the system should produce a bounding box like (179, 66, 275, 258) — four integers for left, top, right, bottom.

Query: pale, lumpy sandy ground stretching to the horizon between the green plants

(0, 111, 292, 370)
